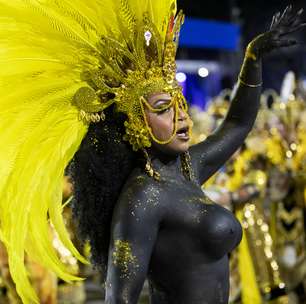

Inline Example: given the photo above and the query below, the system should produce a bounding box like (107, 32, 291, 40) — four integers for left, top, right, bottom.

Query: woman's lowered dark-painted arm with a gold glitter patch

(106, 180, 160, 304)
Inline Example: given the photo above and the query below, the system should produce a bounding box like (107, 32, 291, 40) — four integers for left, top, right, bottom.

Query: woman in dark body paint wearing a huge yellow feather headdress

(0, 0, 302, 303)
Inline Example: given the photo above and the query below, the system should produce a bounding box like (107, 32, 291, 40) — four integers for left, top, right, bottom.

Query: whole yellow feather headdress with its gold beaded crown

(0, 0, 186, 303)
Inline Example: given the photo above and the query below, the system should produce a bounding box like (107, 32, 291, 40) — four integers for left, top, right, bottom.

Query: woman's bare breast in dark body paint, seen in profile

(166, 195, 242, 260)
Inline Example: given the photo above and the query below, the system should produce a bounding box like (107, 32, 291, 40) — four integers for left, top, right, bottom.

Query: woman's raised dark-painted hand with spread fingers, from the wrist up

(247, 5, 306, 60)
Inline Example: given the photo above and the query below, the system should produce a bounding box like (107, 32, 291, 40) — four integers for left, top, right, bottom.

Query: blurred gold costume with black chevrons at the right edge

(265, 95, 306, 301)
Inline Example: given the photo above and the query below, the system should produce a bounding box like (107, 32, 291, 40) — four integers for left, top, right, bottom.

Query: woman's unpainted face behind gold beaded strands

(145, 93, 191, 155)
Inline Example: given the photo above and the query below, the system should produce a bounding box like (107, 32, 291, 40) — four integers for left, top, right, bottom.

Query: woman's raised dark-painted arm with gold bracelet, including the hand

(190, 6, 305, 184)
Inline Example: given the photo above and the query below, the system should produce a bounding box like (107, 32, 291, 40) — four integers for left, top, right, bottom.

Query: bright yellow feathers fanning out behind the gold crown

(0, 0, 176, 303)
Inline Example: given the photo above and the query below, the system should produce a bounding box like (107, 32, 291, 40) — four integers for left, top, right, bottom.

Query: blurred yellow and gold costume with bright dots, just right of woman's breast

(227, 150, 288, 304)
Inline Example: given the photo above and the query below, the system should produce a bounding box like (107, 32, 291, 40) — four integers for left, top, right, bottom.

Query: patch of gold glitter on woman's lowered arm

(113, 240, 137, 277)
